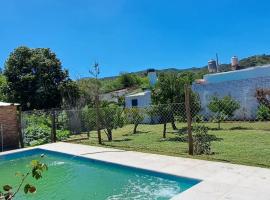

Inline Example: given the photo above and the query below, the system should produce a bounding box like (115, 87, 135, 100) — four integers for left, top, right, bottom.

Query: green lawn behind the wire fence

(68, 122, 270, 168)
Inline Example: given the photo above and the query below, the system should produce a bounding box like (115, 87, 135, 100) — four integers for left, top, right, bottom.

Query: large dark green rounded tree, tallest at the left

(4, 46, 76, 110)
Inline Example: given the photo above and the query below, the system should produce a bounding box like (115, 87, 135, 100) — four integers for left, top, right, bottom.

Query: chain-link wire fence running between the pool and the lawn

(21, 86, 270, 153)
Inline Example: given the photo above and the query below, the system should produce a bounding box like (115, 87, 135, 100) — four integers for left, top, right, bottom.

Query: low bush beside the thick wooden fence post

(192, 126, 211, 155)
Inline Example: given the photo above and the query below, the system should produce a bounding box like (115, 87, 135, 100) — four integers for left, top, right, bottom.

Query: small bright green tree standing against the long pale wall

(208, 96, 240, 129)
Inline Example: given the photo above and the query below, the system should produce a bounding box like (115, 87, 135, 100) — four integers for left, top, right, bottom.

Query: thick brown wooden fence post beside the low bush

(185, 84, 193, 155)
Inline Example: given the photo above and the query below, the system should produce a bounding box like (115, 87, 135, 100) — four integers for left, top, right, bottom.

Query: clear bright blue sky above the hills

(0, 0, 270, 79)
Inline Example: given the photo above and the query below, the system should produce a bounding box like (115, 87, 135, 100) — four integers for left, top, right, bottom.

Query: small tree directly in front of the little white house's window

(125, 108, 145, 134)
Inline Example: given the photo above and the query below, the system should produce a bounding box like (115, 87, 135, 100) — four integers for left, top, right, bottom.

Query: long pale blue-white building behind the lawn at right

(192, 56, 270, 119)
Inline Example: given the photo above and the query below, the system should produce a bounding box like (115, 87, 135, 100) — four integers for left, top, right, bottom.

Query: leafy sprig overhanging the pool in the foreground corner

(0, 160, 48, 200)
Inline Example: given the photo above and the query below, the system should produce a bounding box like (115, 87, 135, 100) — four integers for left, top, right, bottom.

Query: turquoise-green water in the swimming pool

(0, 149, 199, 200)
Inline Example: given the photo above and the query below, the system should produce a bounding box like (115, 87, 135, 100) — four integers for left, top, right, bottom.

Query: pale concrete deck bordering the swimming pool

(0, 142, 270, 200)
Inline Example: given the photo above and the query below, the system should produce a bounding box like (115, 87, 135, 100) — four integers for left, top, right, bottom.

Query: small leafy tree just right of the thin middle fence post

(100, 102, 124, 142)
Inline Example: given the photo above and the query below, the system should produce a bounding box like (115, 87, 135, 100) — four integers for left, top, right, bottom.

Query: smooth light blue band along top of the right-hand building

(203, 64, 270, 84)
